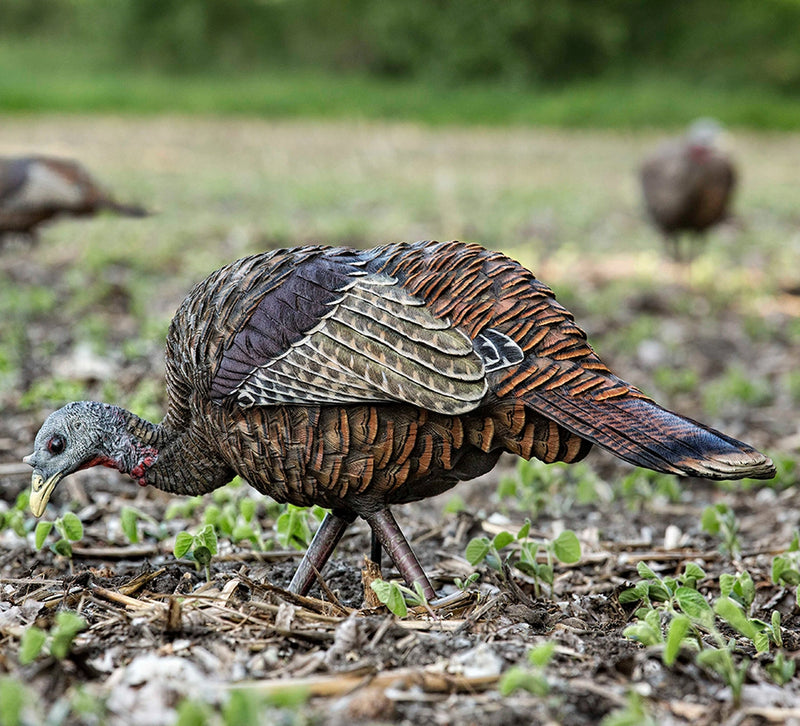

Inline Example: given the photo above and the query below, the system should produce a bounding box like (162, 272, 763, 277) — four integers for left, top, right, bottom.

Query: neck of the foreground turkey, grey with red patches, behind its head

(97, 406, 234, 495)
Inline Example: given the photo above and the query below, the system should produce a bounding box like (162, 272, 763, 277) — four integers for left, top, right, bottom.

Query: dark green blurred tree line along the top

(0, 0, 800, 91)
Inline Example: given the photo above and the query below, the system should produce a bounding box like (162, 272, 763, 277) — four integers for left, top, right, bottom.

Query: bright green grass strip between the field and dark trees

(0, 39, 800, 129)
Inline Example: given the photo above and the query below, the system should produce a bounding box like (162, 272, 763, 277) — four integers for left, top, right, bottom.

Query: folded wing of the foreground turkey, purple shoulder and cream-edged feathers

(214, 268, 488, 414)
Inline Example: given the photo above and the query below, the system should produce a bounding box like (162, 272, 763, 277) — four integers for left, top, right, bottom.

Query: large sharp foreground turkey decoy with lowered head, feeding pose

(25, 242, 774, 597)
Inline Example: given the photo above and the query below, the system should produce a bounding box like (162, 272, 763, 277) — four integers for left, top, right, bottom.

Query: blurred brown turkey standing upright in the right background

(641, 119, 736, 260)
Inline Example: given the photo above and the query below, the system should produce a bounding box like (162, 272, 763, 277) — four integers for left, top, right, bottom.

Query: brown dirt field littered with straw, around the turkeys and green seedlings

(0, 117, 800, 725)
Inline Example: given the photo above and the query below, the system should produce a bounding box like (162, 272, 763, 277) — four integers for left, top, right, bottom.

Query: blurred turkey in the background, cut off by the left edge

(0, 156, 147, 242)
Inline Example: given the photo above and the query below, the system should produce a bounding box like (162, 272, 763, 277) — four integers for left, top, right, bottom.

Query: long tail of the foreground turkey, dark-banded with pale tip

(525, 389, 775, 479)
